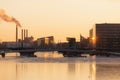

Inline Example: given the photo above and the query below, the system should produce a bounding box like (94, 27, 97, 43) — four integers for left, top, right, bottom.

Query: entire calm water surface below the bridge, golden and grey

(0, 52, 120, 80)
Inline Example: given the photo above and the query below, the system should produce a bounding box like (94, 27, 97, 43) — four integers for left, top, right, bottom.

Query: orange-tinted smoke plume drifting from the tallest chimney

(0, 9, 21, 27)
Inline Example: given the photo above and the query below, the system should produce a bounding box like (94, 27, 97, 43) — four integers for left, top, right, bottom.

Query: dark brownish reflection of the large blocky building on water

(96, 64, 120, 80)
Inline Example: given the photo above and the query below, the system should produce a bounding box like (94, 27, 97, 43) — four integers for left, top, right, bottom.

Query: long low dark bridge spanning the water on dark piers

(0, 49, 120, 58)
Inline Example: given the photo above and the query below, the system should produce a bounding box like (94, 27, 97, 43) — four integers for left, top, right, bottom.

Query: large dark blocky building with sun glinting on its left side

(90, 23, 120, 50)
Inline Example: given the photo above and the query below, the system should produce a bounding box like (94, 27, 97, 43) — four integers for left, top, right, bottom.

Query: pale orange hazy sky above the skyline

(0, 0, 120, 42)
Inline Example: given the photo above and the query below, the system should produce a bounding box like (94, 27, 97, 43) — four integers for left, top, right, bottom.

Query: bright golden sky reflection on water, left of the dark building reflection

(0, 62, 95, 80)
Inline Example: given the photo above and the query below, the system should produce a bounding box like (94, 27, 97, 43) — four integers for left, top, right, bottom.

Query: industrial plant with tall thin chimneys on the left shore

(0, 26, 34, 49)
